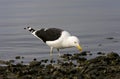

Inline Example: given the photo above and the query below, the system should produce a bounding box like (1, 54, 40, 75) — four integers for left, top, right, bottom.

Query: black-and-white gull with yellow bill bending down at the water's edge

(24, 27, 82, 56)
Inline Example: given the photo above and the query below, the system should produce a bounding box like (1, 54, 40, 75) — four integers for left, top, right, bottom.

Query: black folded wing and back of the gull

(35, 28, 63, 42)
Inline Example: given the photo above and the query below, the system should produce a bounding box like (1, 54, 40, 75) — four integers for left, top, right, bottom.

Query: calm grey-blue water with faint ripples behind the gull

(0, 0, 120, 61)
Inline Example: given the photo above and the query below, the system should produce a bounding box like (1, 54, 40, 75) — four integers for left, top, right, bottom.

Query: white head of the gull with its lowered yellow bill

(69, 36, 82, 52)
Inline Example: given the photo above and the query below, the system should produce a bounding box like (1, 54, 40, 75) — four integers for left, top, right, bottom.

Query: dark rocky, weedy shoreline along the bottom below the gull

(0, 52, 120, 79)
